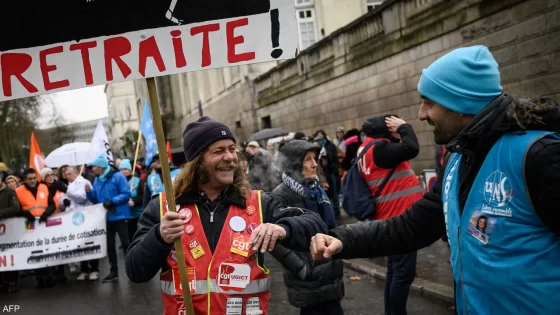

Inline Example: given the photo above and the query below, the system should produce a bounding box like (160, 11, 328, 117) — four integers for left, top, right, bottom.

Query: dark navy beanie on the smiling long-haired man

(183, 116, 235, 163)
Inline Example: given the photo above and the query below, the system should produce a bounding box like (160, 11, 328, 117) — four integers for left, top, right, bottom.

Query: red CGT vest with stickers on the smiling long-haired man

(160, 191, 270, 315)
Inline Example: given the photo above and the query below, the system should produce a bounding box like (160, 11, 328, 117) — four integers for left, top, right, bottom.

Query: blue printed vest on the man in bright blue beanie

(442, 131, 560, 315)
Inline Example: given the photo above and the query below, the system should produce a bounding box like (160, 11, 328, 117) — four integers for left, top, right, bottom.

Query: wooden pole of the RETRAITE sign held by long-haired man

(146, 78, 195, 315)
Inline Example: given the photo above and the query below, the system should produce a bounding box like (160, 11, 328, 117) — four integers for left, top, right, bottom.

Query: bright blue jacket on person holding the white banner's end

(87, 169, 131, 221)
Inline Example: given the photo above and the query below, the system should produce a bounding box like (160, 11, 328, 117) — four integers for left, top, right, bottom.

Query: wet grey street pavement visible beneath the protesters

(0, 251, 453, 315)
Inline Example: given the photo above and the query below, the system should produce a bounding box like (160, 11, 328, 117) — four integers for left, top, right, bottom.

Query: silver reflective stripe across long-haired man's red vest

(160, 278, 270, 295)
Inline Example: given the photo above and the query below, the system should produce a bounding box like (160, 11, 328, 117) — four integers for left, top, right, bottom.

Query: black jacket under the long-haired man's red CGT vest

(125, 188, 327, 283)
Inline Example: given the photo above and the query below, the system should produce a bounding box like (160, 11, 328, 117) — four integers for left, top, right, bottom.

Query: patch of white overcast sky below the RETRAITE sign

(39, 85, 108, 128)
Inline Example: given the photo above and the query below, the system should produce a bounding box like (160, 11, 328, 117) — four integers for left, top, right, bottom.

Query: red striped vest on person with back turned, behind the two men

(358, 137, 423, 220)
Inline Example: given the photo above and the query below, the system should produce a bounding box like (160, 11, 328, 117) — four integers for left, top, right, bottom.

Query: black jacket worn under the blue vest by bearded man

(330, 94, 560, 258)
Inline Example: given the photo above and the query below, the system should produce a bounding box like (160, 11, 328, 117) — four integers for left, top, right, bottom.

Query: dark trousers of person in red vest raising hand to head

(385, 252, 416, 315)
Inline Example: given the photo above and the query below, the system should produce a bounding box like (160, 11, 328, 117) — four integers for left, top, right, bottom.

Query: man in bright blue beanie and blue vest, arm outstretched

(311, 46, 560, 314)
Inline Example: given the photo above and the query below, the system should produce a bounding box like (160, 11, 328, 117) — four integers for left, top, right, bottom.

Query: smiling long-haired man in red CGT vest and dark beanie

(126, 117, 327, 315)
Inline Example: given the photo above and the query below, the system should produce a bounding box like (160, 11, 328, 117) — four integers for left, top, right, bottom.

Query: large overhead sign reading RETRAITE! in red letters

(0, 0, 299, 101)
